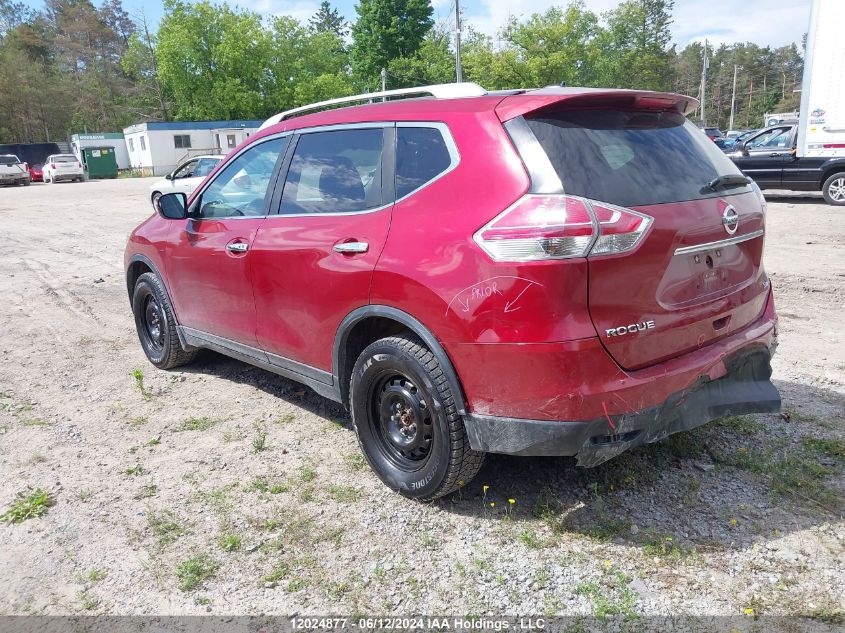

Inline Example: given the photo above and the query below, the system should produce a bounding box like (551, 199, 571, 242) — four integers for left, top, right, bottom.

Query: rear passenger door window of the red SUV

(280, 128, 384, 215)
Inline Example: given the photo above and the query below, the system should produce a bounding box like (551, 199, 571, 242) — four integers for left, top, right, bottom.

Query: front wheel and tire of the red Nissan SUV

(132, 273, 197, 369)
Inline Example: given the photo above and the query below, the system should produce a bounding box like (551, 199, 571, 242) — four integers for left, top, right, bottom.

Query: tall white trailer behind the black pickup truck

(796, 0, 845, 158)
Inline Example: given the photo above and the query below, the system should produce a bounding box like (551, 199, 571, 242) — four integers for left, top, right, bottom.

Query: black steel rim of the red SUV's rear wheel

(370, 372, 434, 471)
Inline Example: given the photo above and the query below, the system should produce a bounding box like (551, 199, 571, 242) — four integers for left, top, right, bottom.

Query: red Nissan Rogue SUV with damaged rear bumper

(126, 84, 780, 499)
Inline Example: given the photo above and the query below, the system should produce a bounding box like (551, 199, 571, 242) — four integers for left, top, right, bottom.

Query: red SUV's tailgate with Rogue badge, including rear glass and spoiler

(497, 89, 769, 369)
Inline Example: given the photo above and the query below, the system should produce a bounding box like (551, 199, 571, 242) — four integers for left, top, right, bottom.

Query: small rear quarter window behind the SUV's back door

(396, 127, 452, 198)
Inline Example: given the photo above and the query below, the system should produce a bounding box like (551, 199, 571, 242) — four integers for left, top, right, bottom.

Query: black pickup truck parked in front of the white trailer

(728, 123, 845, 206)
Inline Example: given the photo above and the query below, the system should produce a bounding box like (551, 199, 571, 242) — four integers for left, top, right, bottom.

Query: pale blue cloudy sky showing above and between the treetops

(25, 0, 810, 46)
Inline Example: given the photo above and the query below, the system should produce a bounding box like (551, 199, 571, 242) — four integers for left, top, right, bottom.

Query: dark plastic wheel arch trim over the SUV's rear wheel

(332, 305, 467, 415)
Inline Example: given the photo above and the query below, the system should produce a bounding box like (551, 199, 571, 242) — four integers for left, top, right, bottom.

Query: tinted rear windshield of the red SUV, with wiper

(526, 110, 748, 207)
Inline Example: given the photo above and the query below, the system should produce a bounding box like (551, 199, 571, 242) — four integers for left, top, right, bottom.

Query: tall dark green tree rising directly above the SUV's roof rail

(350, 0, 434, 87)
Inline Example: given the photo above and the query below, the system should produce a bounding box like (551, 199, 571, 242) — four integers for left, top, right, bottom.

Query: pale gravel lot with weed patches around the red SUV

(0, 179, 845, 623)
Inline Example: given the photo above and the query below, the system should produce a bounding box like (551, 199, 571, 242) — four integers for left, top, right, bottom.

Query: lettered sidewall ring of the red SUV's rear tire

(350, 341, 451, 499)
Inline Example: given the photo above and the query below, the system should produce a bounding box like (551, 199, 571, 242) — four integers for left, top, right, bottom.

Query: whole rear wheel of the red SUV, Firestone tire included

(349, 335, 484, 501)
